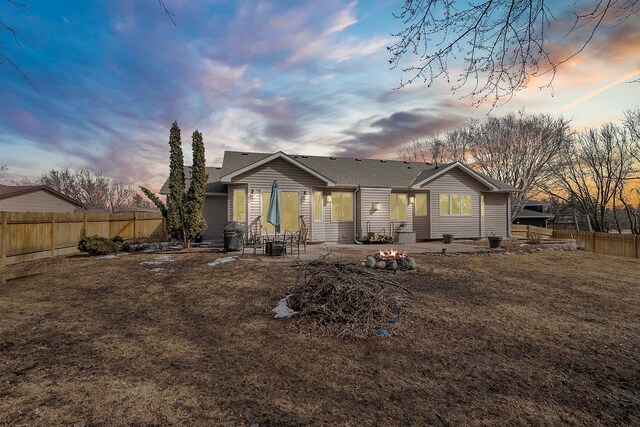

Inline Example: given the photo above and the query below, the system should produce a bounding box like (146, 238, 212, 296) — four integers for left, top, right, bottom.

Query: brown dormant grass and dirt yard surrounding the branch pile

(0, 252, 640, 426)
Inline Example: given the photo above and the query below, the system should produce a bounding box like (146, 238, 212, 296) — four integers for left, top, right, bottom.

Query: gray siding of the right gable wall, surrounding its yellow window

(423, 168, 490, 239)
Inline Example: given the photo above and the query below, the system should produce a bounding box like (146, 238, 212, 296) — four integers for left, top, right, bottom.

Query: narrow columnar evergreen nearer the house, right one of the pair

(184, 130, 209, 243)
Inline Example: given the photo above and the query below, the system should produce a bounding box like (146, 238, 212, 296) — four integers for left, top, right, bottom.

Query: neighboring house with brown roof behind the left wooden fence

(0, 185, 82, 212)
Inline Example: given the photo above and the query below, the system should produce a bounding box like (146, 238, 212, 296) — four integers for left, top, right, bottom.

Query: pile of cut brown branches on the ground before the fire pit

(287, 258, 411, 336)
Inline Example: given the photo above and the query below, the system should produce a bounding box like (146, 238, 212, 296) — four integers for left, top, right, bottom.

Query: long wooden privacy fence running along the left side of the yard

(0, 212, 164, 267)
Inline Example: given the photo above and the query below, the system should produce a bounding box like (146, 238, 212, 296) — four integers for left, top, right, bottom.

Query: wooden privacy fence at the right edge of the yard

(553, 230, 640, 258)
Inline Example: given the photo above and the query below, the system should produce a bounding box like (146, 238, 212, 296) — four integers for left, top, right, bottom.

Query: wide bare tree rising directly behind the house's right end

(398, 111, 572, 218)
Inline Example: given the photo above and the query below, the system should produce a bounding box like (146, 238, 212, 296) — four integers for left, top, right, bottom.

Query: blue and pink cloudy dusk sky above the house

(0, 0, 640, 190)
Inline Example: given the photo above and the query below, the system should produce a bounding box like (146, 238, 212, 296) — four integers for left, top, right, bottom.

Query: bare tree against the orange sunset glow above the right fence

(546, 124, 635, 232)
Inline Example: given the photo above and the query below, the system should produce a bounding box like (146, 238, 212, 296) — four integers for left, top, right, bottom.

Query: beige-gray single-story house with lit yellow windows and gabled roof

(160, 151, 519, 242)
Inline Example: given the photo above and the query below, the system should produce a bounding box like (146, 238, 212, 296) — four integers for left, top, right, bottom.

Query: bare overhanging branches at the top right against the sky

(387, 0, 640, 106)
